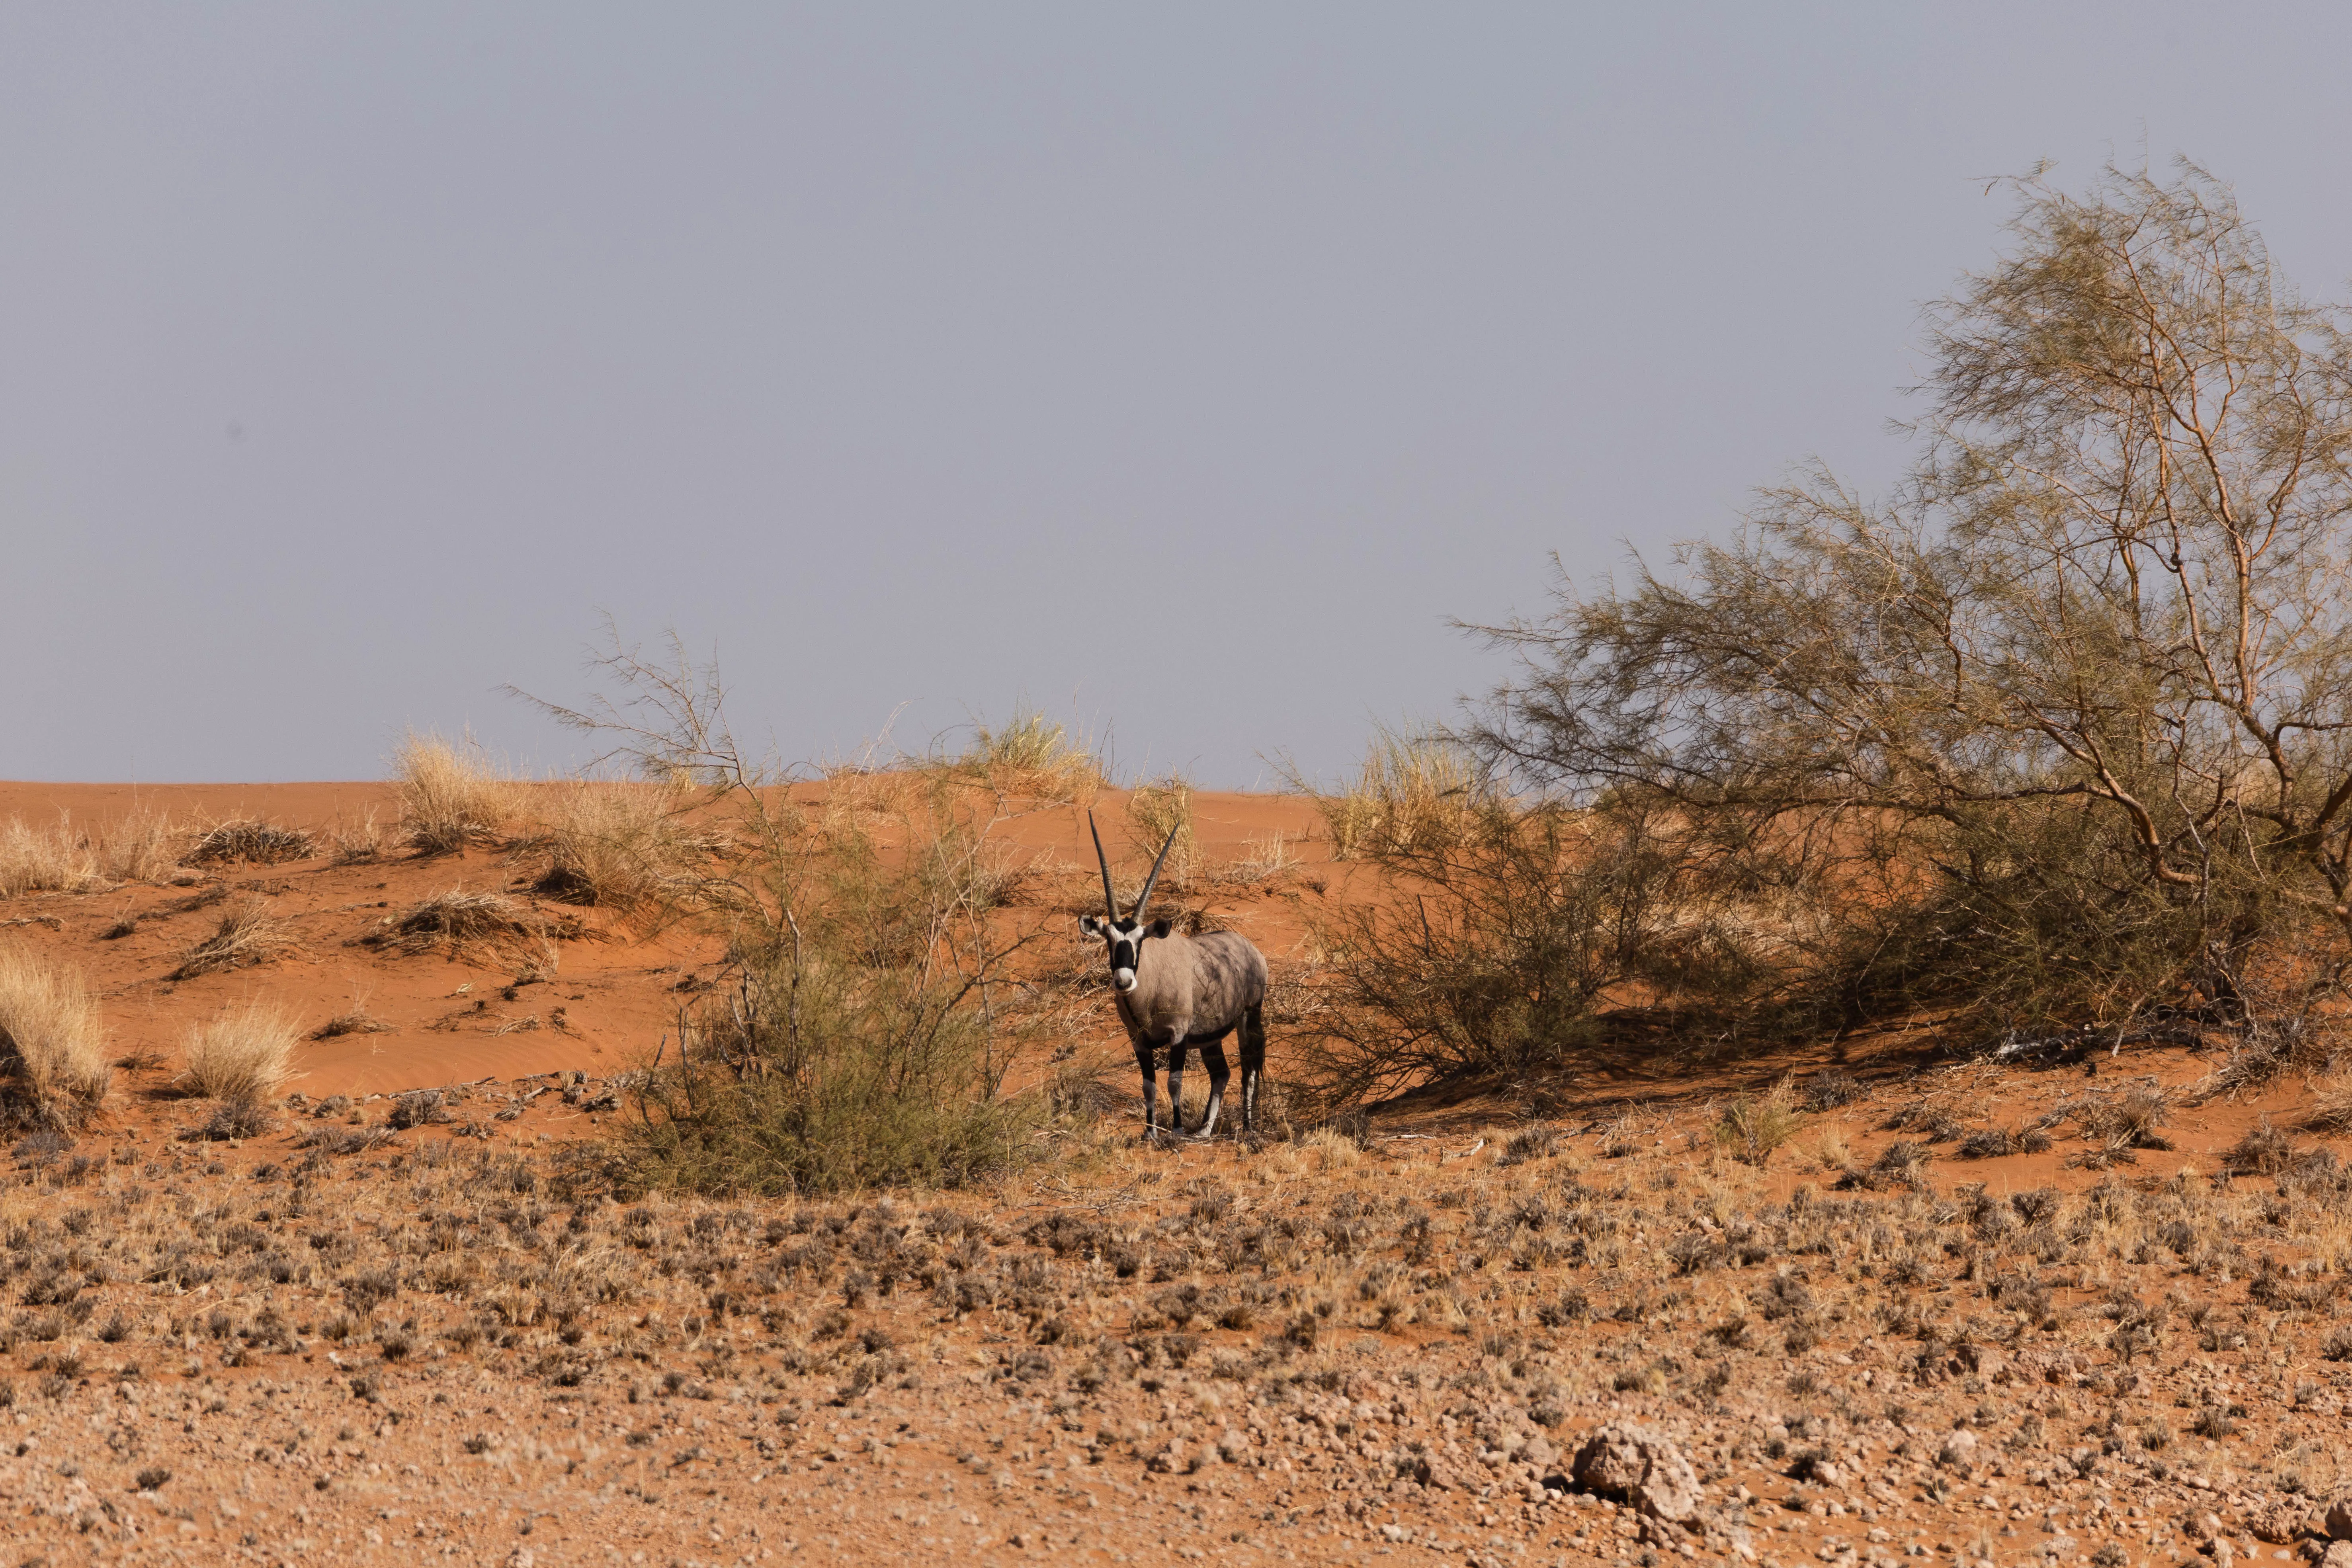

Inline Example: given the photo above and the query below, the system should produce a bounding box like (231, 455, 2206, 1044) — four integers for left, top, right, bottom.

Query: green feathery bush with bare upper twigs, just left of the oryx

(527, 642, 1068, 1194)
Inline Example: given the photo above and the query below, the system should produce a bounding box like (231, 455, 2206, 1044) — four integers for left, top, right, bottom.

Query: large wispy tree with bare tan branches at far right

(1465, 164, 2352, 1048)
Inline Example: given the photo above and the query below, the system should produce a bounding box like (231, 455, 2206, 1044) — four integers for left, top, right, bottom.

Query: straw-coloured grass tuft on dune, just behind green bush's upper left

(522, 781, 708, 910)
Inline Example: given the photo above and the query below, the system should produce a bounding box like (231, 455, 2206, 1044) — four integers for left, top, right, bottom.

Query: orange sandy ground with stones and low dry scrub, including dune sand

(0, 785, 2352, 1568)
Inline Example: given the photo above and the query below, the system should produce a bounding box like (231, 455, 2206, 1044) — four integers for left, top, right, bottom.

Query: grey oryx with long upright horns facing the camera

(1077, 811, 1266, 1140)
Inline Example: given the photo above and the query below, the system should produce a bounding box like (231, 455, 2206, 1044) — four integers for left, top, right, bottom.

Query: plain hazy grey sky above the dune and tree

(0, 0, 2352, 785)
